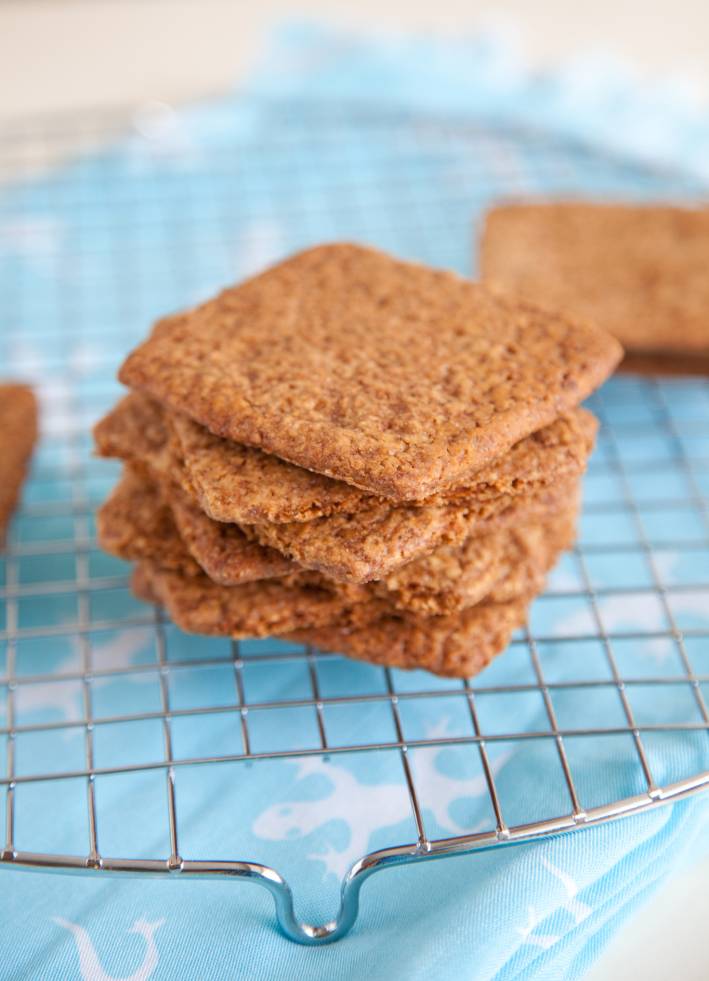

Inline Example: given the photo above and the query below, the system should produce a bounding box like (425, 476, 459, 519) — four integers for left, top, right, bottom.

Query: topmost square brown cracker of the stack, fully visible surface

(119, 238, 621, 501)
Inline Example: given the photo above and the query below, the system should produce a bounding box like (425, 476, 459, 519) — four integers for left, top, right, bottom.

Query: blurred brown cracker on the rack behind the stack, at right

(480, 201, 709, 360)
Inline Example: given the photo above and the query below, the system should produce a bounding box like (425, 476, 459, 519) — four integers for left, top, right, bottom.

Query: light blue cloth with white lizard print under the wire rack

(0, 19, 709, 981)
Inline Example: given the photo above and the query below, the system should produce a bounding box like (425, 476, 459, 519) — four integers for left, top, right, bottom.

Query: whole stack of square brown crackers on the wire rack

(95, 245, 621, 676)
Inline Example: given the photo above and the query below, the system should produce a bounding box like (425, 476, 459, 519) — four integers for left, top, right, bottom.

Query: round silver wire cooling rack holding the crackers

(0, 100, 709, 943)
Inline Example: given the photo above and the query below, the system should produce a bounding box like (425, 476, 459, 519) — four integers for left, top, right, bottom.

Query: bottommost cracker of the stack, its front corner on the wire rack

(289, 596, 531, 678)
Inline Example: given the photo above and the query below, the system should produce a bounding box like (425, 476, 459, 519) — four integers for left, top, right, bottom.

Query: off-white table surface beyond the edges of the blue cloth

(0, 0, 709, 981)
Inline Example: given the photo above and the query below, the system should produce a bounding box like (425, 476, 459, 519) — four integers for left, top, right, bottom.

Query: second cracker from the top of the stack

(95, 392, 596, 524)
